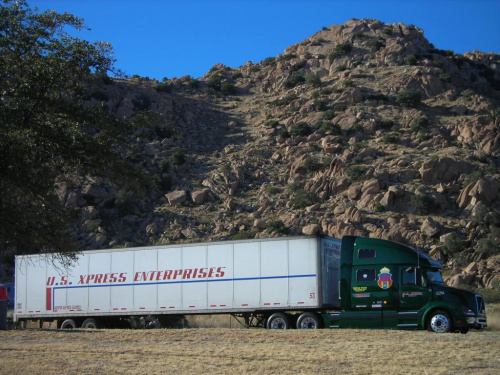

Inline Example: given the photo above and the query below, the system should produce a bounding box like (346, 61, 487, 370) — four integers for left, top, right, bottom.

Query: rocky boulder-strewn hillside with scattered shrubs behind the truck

(53, 20, 500, 288)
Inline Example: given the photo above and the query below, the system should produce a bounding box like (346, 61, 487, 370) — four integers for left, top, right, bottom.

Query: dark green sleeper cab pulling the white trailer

(323, 236, 486, 333)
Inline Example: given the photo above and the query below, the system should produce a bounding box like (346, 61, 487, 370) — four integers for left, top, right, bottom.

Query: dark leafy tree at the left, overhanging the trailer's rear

(0, 0, 131, 254)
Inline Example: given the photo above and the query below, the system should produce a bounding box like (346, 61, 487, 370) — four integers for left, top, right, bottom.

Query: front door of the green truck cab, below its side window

(399, 267, 429, 311)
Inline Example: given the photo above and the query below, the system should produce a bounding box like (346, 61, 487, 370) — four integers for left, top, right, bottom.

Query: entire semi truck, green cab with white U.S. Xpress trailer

(14, 236, 487, 333)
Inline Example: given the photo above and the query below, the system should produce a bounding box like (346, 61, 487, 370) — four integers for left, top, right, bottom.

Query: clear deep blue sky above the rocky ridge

(27, 0, 500, 80)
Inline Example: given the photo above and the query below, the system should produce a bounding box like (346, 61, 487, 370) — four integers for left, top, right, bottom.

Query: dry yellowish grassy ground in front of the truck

(0, 328, 500, 375)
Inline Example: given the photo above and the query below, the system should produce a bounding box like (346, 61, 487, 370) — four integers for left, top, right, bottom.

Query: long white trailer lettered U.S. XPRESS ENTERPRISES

(14, 237, 340, 328)
